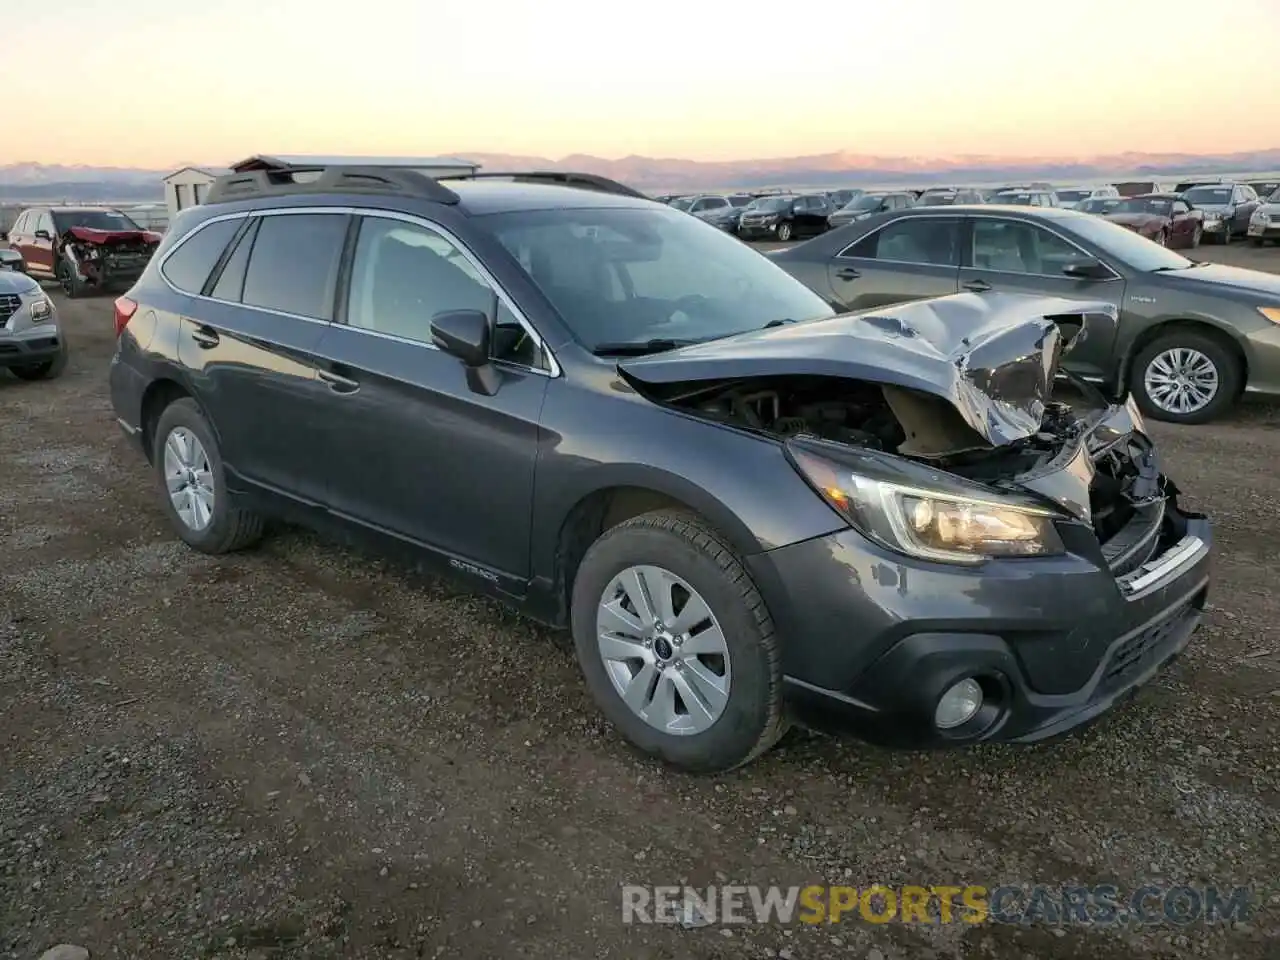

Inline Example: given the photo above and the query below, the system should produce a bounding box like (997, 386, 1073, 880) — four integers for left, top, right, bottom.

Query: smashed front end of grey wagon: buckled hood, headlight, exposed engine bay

(620, 294, 1189, 577)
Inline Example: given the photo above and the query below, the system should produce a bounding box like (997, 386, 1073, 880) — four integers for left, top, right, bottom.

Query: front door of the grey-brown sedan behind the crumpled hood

(960, 215, 1124, 376)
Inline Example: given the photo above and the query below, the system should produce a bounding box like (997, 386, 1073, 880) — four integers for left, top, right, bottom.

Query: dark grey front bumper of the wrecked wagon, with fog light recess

(749, 506, 1212, 748)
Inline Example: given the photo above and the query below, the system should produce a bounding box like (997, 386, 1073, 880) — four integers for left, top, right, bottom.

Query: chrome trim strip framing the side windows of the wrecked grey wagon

(156, 206, 563, 378)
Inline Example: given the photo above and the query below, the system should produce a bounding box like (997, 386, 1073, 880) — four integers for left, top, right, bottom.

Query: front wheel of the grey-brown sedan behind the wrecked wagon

(1130, 330, 1243, 424)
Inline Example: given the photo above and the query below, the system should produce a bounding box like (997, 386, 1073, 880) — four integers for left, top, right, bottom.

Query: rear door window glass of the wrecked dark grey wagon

(241, 214, 348, 320)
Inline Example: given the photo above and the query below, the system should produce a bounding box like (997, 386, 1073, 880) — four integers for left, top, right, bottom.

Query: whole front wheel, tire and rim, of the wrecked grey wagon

(572, 511, 786, 773)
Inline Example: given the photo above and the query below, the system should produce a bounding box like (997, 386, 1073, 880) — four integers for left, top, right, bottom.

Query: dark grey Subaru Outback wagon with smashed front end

(110, 168, 1211, 771)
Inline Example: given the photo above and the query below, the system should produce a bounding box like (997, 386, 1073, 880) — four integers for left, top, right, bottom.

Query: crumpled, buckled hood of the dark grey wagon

(618, 293, 1116, 447)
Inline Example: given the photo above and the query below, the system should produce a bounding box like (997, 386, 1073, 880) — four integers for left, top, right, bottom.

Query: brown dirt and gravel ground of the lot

(0, 248, 1280, 960)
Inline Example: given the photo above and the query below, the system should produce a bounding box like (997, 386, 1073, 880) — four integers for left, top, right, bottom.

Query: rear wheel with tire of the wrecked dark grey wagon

(151, 398, 262, 554)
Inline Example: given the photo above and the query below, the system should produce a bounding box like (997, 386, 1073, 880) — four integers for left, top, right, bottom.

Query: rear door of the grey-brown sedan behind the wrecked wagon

(828, 216, 961, 310)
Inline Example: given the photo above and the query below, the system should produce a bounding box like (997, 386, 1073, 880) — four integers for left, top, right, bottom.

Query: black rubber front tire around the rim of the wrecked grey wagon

(571, 511, 787, 773)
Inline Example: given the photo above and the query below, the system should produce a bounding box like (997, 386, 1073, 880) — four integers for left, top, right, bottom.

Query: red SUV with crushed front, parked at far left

(9, 206, 160, 297)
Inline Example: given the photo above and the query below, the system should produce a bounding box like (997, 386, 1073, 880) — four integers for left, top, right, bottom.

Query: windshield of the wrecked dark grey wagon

(486, 207, 833, 351)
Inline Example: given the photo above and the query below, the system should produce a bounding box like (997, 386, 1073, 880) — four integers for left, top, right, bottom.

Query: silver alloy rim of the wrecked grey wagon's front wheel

(595, 566, 731, 736)
